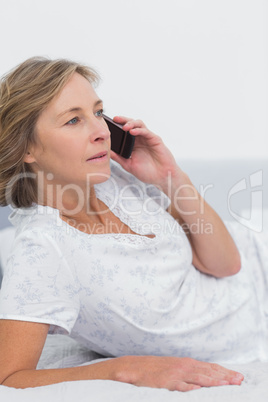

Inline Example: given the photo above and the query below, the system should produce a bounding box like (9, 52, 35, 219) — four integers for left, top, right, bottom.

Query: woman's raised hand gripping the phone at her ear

(111, 116, 182, 192)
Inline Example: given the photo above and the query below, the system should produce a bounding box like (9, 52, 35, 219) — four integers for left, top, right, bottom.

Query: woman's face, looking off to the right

(25, 73, 110, 190)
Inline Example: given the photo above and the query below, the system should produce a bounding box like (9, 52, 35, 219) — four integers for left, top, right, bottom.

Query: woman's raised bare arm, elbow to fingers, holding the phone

(111, 116, 241, 277)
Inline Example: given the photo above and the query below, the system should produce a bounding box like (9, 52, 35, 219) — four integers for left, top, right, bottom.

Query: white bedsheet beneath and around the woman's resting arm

(0, 335, 268, 402)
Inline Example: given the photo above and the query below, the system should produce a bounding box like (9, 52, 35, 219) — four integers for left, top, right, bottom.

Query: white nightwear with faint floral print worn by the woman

(0, 161, 268, 363)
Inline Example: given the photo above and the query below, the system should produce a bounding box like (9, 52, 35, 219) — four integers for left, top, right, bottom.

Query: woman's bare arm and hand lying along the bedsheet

(0, 320, 243, 391)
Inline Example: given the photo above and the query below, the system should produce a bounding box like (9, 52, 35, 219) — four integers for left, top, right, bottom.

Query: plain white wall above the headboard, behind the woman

(0, 0, 268, 158)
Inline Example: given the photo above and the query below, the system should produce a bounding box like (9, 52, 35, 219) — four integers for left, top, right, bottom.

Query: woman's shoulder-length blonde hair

(0, 57, 99, 208)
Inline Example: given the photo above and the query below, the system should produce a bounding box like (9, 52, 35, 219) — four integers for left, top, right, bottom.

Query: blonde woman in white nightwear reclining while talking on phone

(0, 58, 267, 391)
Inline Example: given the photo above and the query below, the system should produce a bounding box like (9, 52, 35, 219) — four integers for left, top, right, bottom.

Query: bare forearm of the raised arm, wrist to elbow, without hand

(165, 173, 241, 278)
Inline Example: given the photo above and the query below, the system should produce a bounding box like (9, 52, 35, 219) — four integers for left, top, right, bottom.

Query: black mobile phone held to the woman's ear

(102, 114, 135, 159)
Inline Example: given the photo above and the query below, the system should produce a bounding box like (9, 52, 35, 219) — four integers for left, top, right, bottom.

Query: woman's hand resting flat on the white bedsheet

(115, 356, 244, 391)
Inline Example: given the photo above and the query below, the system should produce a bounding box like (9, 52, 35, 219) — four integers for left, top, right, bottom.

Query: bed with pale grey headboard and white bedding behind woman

(0, 160, 268, 402)
